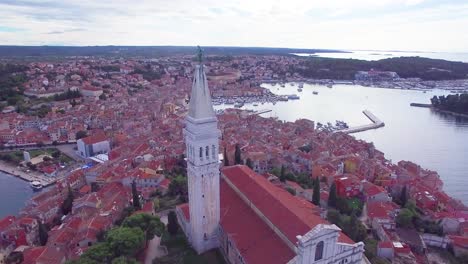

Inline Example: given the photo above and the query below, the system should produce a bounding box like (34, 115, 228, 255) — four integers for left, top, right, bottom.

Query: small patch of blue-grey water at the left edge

(0, 171, 33, 218)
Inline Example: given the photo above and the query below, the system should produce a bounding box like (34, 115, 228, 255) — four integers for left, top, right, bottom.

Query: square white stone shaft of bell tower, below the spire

(184, 117, 220, 253)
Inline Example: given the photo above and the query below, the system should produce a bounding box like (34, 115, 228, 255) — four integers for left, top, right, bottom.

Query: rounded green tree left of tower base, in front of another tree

(106, 227, 145, 257)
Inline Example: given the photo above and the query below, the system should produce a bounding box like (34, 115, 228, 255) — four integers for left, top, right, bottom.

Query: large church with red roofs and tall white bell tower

(176, 52, 365, 264)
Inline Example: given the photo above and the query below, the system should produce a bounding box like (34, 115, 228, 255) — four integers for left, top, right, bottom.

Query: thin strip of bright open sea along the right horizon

(295, 50, 468, 62)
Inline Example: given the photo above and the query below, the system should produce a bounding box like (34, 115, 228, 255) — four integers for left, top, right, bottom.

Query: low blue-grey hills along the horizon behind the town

(0, 46, 345, 58)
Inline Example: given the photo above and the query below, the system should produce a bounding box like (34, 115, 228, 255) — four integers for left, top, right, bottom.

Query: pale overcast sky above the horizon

(0, 0, 468, 52)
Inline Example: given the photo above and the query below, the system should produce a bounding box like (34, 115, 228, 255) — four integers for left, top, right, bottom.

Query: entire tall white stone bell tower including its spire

(184, 64, 221, 254)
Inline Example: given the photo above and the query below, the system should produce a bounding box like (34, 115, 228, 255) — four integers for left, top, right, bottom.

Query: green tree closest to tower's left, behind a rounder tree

(123, 213, 164, 241)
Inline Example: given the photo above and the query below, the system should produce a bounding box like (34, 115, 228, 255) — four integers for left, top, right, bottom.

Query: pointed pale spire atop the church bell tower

(188, 64, 216, 119)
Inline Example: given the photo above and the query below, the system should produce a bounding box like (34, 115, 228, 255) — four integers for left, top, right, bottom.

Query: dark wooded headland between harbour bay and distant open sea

(290, 57, 468, 80)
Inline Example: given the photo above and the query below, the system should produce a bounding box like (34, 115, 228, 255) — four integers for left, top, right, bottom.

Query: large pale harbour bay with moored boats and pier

(216, 84, 468, 204)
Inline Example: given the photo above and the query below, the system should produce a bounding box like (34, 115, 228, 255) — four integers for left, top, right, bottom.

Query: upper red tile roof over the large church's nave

(221, 165, 354, 244)
